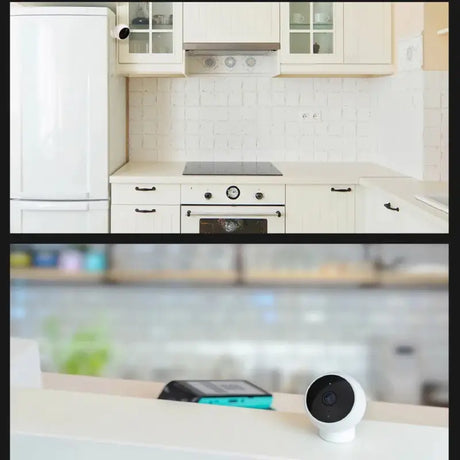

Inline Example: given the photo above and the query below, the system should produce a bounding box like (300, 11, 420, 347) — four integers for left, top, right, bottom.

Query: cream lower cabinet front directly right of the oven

(286, 184, 355, 233)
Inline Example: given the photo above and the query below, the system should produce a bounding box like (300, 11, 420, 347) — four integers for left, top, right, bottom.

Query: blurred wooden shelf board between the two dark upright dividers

(107, 270, 238, 284)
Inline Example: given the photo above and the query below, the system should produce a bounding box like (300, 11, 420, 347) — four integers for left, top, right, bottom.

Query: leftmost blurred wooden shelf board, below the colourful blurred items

(10, 267, 106, 282)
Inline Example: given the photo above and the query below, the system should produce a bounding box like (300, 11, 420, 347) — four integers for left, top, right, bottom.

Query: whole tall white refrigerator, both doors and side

(10, 6, 126, 233)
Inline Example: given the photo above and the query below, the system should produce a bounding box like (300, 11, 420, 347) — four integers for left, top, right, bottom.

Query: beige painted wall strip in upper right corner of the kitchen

(423, 2, 449, 70)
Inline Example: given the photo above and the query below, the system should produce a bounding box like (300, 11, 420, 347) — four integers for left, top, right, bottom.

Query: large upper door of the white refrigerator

(10, 14, 108, 200)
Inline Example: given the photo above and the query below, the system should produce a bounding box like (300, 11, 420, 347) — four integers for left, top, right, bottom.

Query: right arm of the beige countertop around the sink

(359, 177, 449, 222)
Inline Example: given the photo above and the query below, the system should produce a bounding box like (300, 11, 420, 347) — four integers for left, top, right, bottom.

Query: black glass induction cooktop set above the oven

(182, 161, 283, 176)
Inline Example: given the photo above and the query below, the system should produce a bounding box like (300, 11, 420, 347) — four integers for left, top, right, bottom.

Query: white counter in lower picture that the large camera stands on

(10, 375, 448, 460)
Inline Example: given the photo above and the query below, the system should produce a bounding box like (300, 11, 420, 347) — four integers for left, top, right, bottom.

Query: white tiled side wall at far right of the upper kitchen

(370, 35, 449, 181)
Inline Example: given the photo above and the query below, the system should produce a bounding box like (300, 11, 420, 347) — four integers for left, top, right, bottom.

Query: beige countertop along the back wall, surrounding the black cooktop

(110, 162, 404, 184)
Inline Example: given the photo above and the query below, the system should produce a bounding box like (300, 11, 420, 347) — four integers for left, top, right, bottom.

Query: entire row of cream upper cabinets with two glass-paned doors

(117, 2, 393, 76)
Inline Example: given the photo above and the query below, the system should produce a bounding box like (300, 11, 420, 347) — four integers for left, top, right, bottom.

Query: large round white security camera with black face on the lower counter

(305, 372, 366, 442)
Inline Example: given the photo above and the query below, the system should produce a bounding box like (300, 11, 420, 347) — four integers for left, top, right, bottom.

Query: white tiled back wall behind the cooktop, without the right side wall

(129, 77, 372, 165)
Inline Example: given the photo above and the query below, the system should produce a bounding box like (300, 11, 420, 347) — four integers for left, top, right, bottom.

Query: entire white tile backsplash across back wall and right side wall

(129, 69, 448, 177)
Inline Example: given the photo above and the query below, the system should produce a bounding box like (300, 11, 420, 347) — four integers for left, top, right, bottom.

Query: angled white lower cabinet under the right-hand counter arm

(356, 186, 448, 233)
